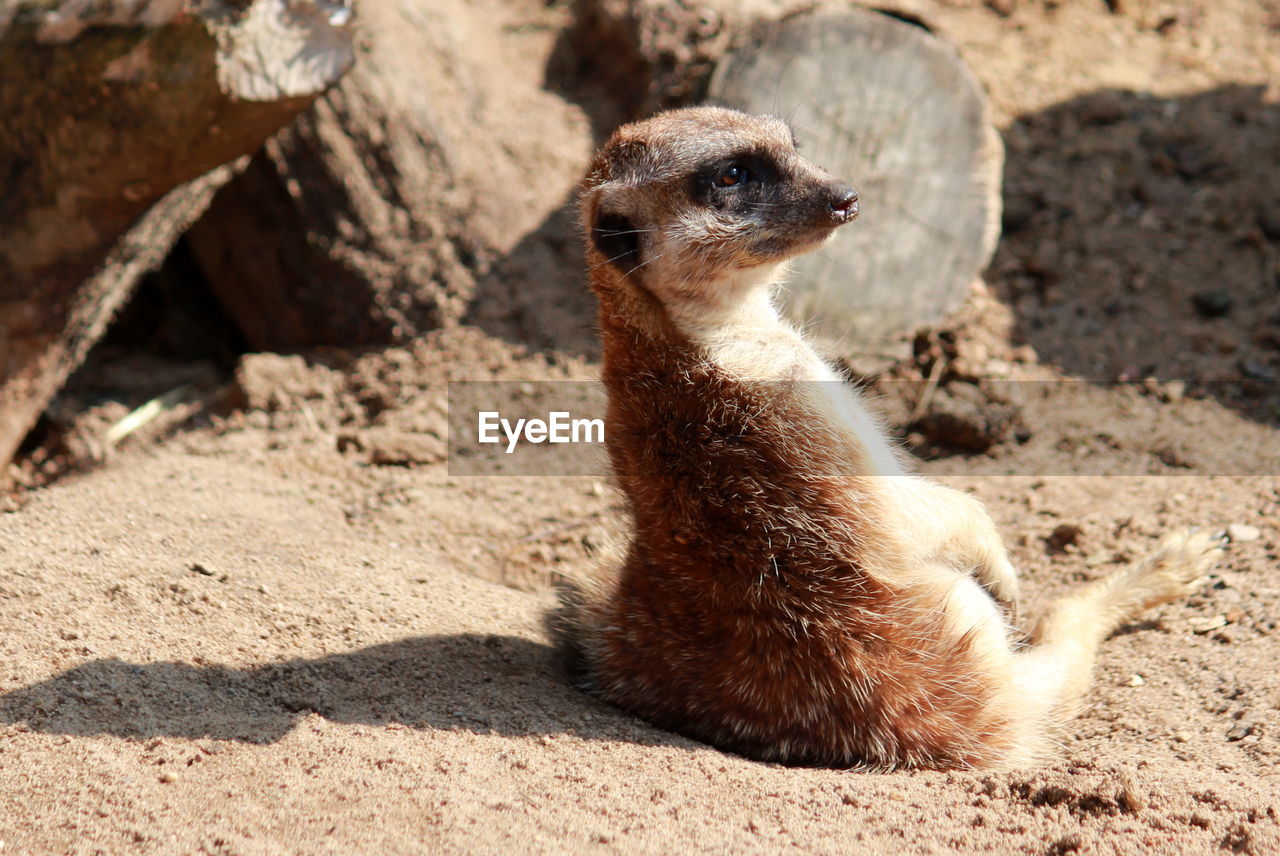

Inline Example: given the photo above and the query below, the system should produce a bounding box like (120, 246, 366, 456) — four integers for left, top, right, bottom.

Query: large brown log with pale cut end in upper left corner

(0, 0, 352, 473)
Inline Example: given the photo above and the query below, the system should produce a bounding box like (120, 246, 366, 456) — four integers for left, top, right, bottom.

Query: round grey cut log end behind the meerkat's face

(710, 9, 1004, 351)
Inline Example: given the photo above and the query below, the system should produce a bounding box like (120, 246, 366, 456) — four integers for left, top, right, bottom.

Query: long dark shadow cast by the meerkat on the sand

(0, 633, 694, 746)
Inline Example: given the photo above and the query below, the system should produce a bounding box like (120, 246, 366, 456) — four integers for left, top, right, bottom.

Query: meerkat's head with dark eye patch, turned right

(581, 107, 858, 312)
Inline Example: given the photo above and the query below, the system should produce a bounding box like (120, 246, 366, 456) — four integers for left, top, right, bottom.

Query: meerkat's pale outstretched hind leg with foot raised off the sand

(1014, 530, 1222, 720)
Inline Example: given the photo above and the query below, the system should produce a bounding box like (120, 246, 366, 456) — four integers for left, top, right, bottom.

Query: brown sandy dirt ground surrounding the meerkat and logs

(0, 0, 1280, 855)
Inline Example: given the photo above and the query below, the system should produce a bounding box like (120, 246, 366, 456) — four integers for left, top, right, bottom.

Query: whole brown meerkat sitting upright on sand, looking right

(575, 107, 1221, 769)
